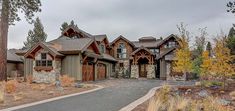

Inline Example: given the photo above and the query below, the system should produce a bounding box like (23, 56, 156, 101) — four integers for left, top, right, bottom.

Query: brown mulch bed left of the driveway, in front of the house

(0, 83, 96, 109)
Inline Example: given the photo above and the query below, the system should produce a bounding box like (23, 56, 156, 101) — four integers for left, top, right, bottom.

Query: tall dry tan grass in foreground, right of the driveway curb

(147, 85, 230, 111)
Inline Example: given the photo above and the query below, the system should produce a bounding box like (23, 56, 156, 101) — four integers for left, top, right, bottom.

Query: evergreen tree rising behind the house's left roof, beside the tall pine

(24, 17, 47, 48)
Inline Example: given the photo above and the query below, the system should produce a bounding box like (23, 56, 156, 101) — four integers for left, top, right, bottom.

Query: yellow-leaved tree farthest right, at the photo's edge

(212, 38, 234, 86)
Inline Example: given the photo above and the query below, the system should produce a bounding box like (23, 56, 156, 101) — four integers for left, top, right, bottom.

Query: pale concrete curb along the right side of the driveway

(119, 86, 161, 111)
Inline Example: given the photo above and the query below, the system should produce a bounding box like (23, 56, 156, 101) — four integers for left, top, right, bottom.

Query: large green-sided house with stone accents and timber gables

(24, 26, 182, 82)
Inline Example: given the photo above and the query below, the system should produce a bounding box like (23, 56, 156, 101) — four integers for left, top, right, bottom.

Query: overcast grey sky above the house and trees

(8, 0, 235, 48)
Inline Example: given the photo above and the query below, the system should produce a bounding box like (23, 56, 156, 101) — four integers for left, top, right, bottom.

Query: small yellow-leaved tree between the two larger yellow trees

(200, 51, 212, 80)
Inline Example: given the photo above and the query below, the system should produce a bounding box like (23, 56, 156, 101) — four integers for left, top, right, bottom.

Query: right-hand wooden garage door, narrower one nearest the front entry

(97, 64, 106, 80)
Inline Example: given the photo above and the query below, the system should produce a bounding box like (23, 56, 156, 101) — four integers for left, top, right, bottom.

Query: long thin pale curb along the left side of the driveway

(0, 85, 104, 111)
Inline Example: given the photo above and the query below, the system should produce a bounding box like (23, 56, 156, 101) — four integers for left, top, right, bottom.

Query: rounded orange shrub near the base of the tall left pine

(5, 80, 17, 93)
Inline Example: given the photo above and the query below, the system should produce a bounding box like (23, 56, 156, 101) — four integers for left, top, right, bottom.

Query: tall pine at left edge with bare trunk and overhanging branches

(0, 0, 41, 80)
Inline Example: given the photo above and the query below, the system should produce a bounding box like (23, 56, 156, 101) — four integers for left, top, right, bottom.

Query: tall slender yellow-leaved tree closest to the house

(173, 23, 192, 80)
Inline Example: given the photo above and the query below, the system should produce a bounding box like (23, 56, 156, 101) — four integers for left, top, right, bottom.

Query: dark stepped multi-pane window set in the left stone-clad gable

(36, 53, 52, 67)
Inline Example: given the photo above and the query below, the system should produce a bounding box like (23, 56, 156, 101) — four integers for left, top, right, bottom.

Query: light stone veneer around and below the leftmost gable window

(33, 60, 61, 83)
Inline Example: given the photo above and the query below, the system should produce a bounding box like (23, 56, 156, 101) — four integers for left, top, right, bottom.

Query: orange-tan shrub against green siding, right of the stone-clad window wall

(60, 75, 75, 87)
